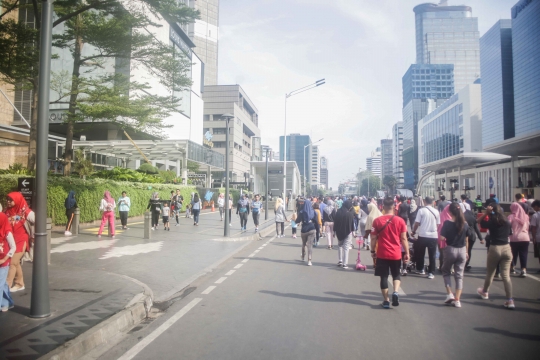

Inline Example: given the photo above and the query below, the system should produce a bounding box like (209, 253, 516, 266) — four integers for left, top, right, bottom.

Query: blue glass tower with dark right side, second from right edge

(480, 20, 515, 146)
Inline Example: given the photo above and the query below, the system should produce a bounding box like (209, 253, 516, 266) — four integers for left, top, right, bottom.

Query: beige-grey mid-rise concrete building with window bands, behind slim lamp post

(204, 85, 262, 182)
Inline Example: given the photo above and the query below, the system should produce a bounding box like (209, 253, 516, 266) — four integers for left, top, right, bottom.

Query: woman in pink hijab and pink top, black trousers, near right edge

(508, 202, 530, 277)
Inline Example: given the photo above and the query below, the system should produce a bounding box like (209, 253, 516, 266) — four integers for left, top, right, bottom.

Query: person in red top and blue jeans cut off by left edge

(0, 212, 17, 312)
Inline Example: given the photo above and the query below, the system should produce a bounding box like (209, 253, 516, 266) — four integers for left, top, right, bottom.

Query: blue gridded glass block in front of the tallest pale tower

(402, 64, 454, 107)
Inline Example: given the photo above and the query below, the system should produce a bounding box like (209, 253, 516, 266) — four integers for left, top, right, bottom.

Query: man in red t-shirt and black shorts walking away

(371, 197, 409, 309)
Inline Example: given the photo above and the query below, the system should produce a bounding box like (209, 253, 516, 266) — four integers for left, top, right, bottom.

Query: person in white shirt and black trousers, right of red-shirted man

(411, 196, 441, 279)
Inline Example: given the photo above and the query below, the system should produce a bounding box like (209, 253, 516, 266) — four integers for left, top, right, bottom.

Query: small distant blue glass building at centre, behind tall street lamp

(279, 134, 312, 183)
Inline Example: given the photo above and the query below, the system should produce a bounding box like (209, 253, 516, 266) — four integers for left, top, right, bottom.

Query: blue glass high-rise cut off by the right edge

(512, 0, 540, 137)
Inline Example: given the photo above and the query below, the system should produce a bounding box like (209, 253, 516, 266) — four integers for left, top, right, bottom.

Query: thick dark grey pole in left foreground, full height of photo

(30, 0, 54, 318)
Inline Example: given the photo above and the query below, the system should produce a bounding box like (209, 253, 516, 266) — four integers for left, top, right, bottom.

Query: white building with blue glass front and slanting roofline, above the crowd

(418, 84, 482, 167)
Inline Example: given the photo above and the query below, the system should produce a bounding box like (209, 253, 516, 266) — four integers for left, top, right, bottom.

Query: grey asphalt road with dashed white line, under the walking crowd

(100, 229, 540, 360)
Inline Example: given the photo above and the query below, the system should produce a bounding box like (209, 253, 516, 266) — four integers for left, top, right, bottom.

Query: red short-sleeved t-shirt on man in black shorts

(371, 215, 407, 260)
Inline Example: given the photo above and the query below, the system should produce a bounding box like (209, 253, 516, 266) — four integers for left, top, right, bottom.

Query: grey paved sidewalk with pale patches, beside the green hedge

(0, 212, 284, 359)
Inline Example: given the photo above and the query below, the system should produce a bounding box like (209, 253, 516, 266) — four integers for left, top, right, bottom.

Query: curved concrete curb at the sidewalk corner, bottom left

(39, 288, 153, 360)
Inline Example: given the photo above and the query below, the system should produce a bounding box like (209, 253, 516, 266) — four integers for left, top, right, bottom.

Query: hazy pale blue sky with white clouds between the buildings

(219, 0, 517, 189)
